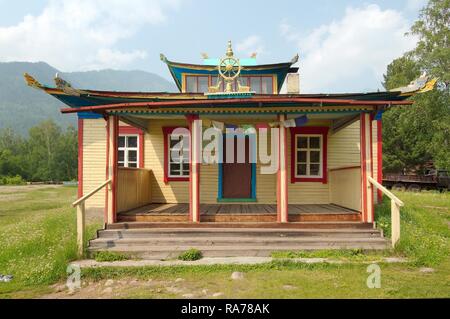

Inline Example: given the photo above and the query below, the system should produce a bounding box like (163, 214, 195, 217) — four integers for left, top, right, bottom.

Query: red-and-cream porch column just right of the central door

(277, 114, 292, 223)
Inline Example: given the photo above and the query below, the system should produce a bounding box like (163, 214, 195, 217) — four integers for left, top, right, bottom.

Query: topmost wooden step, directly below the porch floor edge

(107, 221, 373, 229)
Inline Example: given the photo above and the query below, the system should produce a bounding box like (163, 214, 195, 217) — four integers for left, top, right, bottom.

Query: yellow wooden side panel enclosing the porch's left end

(117, 167, 151, 213)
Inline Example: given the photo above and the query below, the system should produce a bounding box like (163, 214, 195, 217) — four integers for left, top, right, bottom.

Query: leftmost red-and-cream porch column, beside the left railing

(106, 115, 119, 224)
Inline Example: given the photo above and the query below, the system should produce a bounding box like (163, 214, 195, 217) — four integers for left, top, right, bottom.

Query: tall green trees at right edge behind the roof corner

(383, 0, 450, 172)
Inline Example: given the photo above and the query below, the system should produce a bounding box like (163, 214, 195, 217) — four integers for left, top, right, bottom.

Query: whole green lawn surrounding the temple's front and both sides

(0, 186, 450, 298)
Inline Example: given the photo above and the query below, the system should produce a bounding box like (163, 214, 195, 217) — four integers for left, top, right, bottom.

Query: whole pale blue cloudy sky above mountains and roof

(0, 0, 426, 93)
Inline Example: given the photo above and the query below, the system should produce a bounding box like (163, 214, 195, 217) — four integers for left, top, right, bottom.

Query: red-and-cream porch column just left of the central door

(186, 115, 202, 223)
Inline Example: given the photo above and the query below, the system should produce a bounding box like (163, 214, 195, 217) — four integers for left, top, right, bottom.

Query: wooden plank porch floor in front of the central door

(118, 204, 361, 222)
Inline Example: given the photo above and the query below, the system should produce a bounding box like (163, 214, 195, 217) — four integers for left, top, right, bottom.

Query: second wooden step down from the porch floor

(98, 228, 381, 239)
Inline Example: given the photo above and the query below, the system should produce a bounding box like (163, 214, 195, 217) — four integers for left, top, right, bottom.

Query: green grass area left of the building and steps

(0, 187, 99, 298)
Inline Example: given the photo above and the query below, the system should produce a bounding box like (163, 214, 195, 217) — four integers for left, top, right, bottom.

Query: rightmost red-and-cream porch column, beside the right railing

(360, 113, 374, 223)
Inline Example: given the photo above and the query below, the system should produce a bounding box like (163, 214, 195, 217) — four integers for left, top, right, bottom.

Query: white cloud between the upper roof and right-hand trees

(280, 5, 417, 93)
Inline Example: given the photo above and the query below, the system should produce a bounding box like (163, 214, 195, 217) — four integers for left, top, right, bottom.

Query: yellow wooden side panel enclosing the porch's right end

(329, 166, 361, 210)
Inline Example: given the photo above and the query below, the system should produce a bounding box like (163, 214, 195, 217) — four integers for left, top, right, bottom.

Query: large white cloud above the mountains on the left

(0, 0, 181, 71)
